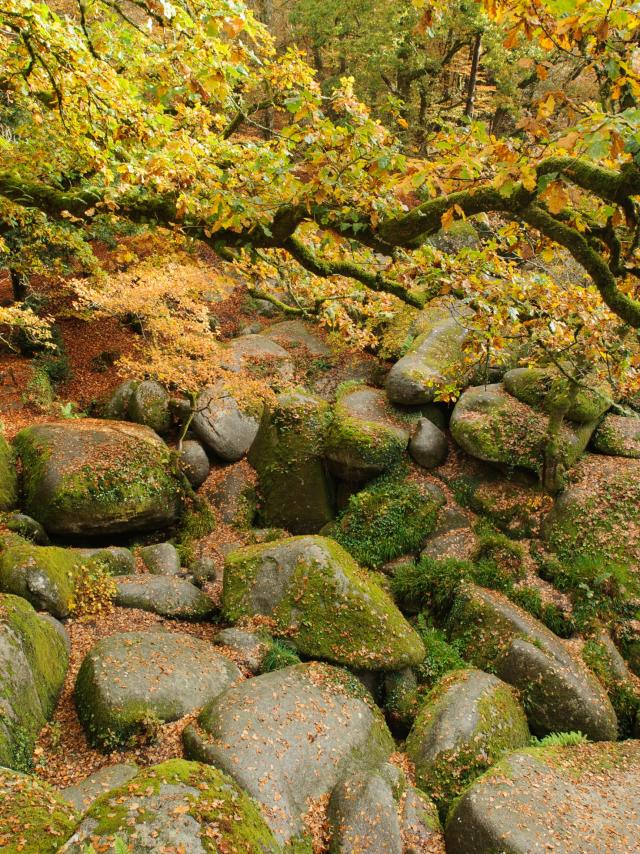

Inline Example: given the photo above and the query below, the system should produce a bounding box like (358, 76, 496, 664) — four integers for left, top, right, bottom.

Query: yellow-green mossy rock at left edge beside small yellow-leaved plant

(0, 534, 85, 618)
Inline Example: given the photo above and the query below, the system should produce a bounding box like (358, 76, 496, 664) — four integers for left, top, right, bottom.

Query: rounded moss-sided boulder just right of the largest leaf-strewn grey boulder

(406, 670, 530, 810)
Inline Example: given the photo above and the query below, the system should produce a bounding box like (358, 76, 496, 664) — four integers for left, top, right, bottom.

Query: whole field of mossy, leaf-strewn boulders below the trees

(0, 314, 640, 854)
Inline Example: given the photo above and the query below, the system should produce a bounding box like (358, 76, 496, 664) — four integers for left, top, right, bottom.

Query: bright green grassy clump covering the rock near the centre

(333, 472, 438, 569)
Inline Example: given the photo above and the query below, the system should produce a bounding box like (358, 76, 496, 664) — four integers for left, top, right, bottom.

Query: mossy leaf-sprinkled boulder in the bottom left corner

(0, 768, 79, 854)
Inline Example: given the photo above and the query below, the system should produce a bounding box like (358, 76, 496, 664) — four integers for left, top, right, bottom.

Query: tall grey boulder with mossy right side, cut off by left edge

(0, 595, 69, 768)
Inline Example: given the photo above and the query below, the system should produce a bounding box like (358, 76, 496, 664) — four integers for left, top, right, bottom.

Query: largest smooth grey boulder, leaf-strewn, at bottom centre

(184, 663, 394, 842)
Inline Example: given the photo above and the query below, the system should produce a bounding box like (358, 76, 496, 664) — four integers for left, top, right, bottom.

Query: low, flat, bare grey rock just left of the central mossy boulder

(115, 575, 214, 620)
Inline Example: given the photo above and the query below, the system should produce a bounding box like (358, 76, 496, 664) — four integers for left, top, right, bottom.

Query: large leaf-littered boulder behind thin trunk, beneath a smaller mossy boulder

(449, 383, 595, 473)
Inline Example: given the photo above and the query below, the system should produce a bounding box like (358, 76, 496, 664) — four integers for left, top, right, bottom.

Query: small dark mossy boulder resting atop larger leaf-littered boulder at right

(502, 368, 612, 424)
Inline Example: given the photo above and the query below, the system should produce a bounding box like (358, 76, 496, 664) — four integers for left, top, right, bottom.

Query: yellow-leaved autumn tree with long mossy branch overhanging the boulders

(0, 0, 640, 402)
